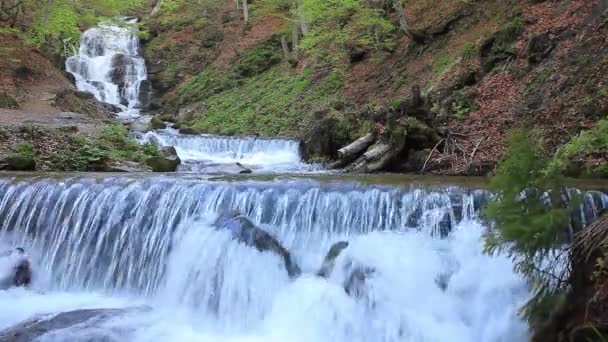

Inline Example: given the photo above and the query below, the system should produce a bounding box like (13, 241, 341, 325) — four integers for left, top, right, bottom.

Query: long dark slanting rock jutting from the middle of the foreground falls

(215, 212, 302, 278)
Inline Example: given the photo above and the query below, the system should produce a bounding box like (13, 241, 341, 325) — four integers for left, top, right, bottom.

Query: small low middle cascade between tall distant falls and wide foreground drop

(139, 129, 320, 173)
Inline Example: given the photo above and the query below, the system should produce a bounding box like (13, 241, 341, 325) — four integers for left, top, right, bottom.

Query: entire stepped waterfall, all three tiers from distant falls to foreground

(0, 19, 608, 342)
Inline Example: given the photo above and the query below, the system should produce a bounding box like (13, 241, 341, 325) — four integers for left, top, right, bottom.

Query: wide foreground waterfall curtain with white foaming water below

(0, 177, 608, 342)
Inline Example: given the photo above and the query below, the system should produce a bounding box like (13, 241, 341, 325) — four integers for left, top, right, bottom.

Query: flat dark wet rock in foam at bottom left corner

(0, 307, 149, 342)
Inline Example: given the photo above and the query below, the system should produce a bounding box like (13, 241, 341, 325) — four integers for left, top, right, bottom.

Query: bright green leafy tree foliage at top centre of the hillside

(297, 0, 395, 64)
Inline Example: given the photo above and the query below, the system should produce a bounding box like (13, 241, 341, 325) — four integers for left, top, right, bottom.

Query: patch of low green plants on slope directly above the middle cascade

(185, 64, 343, 136)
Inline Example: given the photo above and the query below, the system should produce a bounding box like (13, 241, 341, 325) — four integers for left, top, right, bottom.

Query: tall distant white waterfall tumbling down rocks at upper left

(66, 19, 151, 119)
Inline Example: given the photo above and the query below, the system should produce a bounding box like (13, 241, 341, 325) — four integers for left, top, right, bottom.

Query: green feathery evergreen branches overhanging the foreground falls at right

(484, 120, 608, 322)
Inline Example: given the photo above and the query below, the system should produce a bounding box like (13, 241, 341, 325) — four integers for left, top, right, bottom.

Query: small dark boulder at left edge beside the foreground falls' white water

(0, 247, 32, 290)
